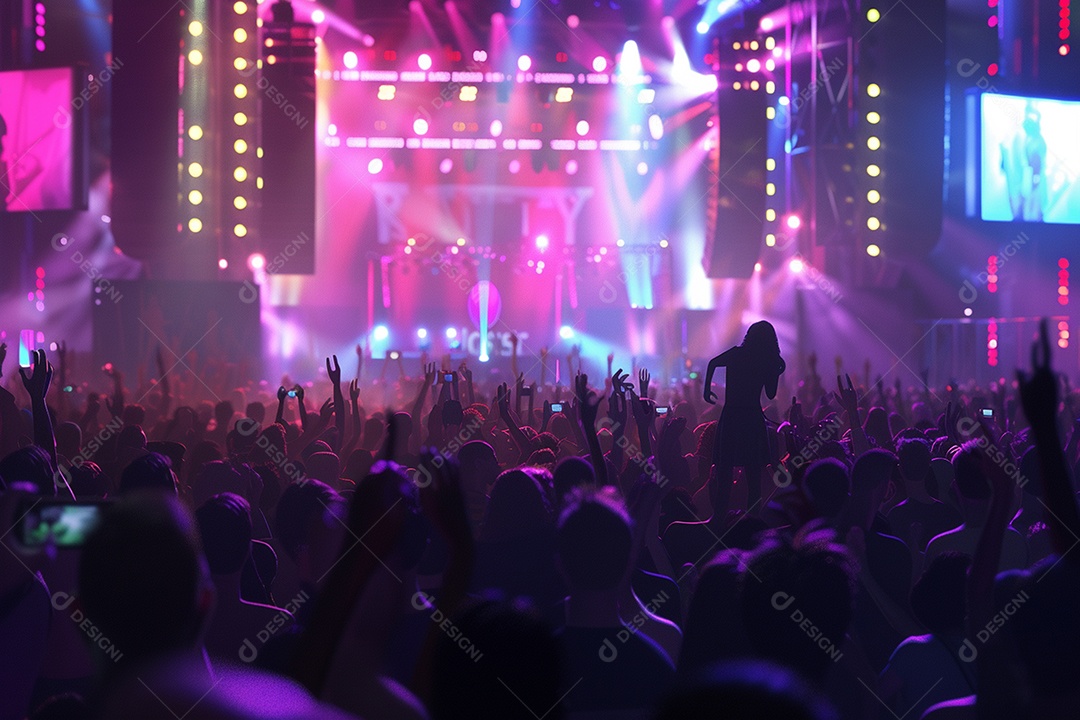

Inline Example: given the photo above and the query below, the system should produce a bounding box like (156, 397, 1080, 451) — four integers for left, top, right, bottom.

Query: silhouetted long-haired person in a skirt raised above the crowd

(705, 321, 787, 510)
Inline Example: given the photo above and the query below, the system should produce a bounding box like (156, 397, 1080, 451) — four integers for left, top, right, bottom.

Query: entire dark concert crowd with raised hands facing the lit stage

(0, 323, 1080, 720)
